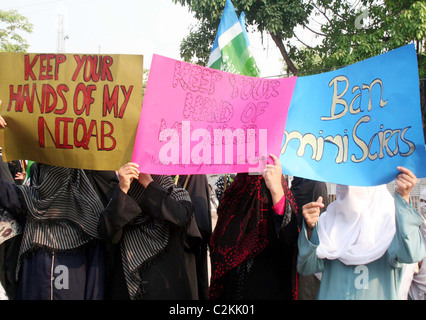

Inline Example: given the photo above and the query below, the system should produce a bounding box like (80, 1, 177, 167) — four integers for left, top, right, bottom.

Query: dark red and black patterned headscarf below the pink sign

(209, 173, 297, 299)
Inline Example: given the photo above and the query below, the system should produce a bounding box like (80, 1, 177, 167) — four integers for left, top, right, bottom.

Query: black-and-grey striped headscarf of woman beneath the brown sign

(18, 164, 103, 252)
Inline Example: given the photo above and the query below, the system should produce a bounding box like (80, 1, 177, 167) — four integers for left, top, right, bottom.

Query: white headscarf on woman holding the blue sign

(317, 185, 395, 265)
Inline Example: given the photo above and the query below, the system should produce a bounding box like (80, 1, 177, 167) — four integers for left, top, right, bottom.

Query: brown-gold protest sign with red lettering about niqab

(0, 53, 143, 170)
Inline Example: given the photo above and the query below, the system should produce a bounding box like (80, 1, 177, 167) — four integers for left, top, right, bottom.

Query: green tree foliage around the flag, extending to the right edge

(173, 0, 426, 77)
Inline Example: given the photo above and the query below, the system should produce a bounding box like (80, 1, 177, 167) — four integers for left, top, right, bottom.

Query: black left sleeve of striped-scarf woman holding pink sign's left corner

(98, 185, 142, 243)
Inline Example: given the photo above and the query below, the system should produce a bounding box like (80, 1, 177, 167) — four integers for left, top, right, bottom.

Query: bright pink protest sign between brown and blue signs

(132, 55, 296, 175)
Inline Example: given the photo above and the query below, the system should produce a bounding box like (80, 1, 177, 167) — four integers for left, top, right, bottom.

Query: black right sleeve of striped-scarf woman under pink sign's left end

(139, 181, 194, 228)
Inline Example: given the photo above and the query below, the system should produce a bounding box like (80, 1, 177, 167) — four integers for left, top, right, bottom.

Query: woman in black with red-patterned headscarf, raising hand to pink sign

(209, 155, 298, 300)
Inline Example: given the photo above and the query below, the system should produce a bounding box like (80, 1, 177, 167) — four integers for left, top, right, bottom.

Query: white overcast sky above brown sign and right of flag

(0, 0, 290, 77)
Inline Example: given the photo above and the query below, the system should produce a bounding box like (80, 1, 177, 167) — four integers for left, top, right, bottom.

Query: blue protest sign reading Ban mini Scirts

(280, 45, 426, 186)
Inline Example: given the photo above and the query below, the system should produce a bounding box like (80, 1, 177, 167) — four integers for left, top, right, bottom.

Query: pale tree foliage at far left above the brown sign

(0, 10, 33, 52)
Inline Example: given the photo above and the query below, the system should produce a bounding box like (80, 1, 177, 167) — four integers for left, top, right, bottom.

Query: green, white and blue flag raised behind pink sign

(207, 0, 260, 77)
